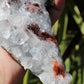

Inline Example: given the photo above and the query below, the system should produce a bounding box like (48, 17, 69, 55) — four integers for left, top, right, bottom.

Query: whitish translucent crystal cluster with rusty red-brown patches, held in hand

(0, 0, 72, 84)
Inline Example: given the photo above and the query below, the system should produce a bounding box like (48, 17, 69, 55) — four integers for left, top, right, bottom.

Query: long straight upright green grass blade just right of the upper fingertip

(58, 9, 68, 44)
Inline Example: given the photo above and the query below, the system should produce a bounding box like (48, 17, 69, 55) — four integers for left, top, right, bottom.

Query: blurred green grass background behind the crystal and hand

(23, 0, 84, 84)
